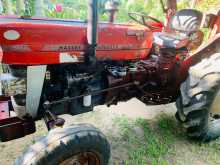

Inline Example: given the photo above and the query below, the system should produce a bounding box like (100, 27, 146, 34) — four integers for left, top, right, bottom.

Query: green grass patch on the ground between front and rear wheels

(115, 116, 180, 165)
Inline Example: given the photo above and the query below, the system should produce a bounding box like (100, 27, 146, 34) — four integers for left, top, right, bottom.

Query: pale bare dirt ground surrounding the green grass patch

(0, 99, 220, 165)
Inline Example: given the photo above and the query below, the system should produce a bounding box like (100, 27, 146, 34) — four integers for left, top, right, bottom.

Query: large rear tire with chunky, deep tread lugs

(176, 53, 220, 141)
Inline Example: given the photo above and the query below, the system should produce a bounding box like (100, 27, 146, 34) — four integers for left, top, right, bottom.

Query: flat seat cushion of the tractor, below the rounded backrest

(153, 32, 189, 49)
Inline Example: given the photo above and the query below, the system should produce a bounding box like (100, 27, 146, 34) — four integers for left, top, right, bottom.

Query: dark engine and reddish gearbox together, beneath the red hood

(3, 45, 183, 118)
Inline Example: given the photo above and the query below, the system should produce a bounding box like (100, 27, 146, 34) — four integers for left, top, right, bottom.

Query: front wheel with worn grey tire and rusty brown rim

(15, 124, 110, 165)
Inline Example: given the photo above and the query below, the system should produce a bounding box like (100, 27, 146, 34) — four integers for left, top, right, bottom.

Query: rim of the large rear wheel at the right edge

(210, 90, 220, 121)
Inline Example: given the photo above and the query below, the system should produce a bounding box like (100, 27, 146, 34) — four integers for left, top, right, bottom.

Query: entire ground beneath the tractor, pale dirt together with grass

(0, 99, 220, 165)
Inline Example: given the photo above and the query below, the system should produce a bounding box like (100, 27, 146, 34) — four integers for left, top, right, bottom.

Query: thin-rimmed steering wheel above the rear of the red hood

(128, 12, 163, 30)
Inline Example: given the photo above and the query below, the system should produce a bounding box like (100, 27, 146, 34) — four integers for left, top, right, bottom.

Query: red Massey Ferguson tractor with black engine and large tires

(0, 0, 220, 165)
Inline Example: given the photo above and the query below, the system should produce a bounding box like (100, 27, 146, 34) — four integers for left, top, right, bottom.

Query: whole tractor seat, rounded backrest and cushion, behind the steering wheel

(154, 9, 203, 49)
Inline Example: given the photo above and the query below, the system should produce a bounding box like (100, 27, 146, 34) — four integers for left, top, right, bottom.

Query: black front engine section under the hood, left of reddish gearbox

(2, 64, 108, 118)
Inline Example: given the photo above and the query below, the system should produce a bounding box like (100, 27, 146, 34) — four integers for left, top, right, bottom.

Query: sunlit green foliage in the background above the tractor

(3, 0, 220, 22)
